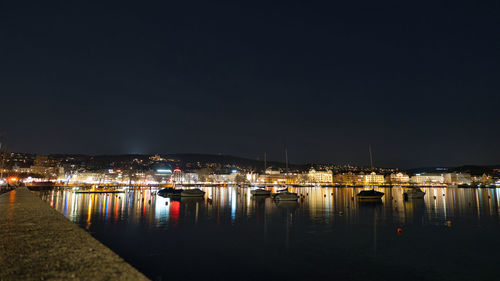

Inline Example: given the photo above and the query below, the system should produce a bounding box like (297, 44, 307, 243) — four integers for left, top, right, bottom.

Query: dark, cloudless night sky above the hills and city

(0, 0, 500, 167)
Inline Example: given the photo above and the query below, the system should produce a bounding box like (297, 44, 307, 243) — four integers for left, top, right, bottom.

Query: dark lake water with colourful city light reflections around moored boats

(40, 187, 500, 281)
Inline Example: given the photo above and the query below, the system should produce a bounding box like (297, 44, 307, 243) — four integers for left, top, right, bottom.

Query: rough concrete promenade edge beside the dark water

(0, 187, 149, 280)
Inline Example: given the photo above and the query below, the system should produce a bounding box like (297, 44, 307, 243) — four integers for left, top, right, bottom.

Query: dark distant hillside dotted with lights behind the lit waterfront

(12, 153, 500, 175)
